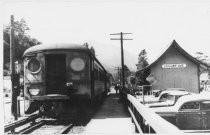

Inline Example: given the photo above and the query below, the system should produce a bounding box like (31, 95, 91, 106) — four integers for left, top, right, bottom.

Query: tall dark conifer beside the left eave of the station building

(136, 49, 150, 85)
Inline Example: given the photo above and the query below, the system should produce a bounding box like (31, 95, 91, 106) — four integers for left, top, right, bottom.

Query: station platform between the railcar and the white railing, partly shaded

(84, 89, 135, 134)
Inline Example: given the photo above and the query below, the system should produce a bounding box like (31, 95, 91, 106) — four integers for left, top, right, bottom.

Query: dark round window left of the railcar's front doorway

(27, 58, 41, 74)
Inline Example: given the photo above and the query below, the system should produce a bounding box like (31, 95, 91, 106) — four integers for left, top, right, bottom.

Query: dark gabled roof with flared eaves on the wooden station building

(137, 40, 208, 72)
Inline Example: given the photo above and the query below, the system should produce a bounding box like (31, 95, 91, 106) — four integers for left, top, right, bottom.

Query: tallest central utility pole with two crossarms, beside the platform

(110, 32, 133, 90)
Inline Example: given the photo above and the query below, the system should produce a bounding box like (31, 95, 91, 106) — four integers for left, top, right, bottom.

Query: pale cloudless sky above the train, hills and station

(3, 0, 210, 70)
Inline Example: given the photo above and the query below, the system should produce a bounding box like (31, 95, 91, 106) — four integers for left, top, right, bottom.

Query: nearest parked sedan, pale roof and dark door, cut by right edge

(151, 94, 210, 130)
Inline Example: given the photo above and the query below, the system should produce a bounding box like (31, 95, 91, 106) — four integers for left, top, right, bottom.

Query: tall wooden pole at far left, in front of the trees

(10, 15, 17, 120)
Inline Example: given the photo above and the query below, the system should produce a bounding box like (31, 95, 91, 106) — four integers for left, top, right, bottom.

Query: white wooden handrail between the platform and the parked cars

(127, 94, 184, 134)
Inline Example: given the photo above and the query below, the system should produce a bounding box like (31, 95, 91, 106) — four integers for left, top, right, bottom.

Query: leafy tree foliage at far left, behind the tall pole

(3, 19, 41, 70)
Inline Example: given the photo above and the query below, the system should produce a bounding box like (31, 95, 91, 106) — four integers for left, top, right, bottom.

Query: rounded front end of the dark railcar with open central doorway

(24, 44, 97, 114)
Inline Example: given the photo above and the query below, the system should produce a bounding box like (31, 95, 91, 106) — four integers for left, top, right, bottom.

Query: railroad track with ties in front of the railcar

(4, 114, 81, 135)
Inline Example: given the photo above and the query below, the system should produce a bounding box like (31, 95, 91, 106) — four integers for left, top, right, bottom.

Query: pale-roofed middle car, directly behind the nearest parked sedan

(146, 90, 191, 108)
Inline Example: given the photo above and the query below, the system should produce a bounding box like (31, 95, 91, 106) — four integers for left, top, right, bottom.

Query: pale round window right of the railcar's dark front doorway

(70, 58, 85, 71)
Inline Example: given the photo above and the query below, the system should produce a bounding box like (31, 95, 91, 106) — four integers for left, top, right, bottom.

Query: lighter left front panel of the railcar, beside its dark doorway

(24, 53, 46, 114)
